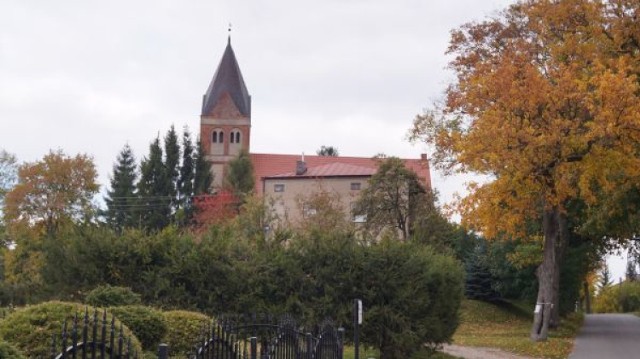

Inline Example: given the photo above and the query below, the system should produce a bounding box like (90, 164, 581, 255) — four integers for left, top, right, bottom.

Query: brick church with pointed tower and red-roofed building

(200, 37, 431, 220)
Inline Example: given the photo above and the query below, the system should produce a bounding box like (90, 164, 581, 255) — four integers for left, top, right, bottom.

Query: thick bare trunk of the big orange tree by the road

(531, 207, 564, 341)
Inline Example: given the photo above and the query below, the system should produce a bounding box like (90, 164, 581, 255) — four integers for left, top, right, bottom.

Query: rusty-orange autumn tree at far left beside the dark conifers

(4, 150, 99, 235)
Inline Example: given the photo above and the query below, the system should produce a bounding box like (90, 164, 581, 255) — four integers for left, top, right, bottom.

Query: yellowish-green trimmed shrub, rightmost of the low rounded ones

(162, 310, 211, 357)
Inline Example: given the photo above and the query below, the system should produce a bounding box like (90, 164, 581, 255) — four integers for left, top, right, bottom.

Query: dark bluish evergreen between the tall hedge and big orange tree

(464, 243, 500, 302)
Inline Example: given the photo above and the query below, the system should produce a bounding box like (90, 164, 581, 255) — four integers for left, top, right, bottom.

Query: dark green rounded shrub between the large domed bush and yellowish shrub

(109, 305, 167, 351)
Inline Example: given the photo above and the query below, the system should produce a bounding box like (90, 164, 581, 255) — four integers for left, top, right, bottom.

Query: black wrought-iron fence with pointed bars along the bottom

(50, 309, 344, 359)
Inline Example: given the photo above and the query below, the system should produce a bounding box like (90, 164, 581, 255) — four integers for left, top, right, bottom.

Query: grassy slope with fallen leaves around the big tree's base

(453, 300, 582, 358)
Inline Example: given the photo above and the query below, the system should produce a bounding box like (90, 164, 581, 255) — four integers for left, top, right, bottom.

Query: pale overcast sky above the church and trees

(0, 0, 619, 275)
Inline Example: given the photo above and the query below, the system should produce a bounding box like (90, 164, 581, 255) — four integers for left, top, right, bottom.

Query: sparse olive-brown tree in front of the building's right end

(353, 157, 426, 240)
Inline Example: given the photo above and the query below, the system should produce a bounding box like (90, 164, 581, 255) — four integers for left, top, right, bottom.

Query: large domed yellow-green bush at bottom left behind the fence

(0, 302, 142, 358)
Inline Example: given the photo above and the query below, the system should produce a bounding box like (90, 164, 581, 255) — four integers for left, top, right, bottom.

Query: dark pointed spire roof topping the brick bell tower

(202, 35, 251, 117)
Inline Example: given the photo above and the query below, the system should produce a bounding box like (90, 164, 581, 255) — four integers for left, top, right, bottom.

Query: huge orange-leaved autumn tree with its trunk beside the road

(413, 0, 640, 340)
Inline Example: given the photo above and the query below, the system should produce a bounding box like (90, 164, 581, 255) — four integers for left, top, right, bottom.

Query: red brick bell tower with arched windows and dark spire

(200, 37, 251, 188)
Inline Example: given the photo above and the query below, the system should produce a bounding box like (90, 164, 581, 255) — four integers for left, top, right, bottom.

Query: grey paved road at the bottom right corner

(569, 314, 640, 359)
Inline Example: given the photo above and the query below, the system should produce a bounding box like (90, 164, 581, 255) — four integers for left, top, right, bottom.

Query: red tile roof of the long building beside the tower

(251, 153, 431, 194)
